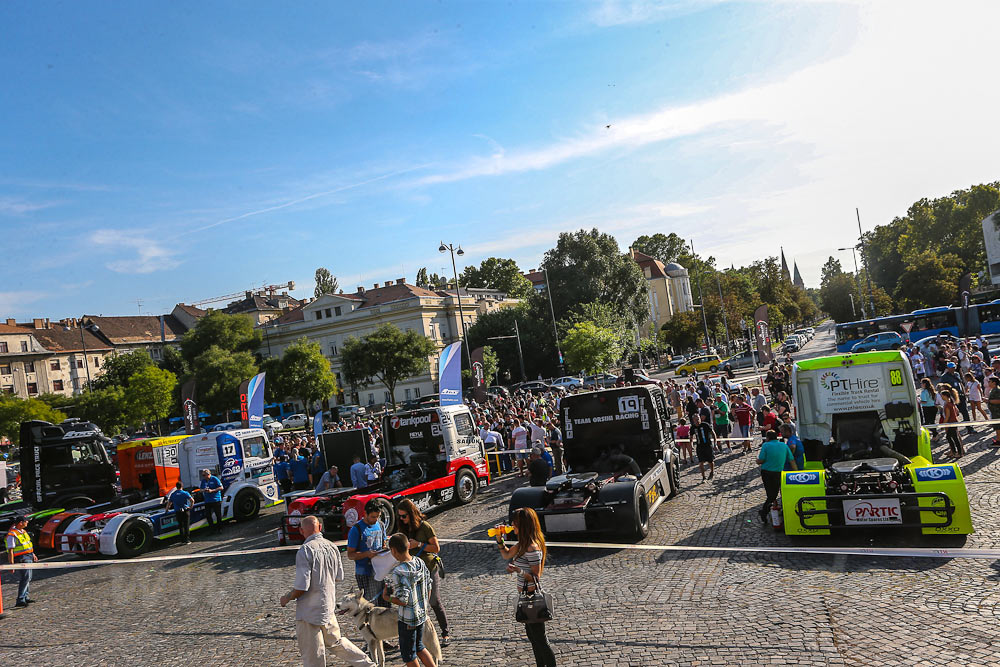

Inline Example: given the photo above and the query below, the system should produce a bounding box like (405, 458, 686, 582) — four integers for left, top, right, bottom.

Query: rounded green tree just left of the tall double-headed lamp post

(341, 324, 437, 407)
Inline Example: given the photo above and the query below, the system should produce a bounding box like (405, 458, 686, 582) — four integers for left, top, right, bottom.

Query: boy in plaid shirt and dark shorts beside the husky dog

(383, 533, 435, 667)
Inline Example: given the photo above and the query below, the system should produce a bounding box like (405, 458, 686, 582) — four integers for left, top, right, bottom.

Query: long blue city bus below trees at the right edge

(835, 299, 1000, 353)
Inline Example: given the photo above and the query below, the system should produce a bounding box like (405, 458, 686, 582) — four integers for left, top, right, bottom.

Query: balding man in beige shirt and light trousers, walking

(279, 516, 375, 667)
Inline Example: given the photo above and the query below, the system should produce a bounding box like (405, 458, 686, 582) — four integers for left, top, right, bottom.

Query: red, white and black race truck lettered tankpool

(279, 405, 490, 544)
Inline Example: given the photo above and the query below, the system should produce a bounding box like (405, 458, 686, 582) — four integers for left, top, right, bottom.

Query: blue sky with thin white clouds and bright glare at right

(0, 0, 1000, 319)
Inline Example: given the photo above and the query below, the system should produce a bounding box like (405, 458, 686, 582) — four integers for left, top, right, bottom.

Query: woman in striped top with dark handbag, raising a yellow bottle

(496, 507, 556, 667)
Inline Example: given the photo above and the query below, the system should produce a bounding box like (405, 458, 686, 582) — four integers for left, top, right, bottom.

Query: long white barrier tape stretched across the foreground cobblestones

(0, 538, 1000, 571)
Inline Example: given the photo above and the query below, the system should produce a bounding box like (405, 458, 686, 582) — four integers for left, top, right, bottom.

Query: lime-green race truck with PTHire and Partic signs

(781, 350, 973, 535)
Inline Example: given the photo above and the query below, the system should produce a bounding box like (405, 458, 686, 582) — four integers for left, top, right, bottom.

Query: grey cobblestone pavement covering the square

(0, 326, 1000, 667)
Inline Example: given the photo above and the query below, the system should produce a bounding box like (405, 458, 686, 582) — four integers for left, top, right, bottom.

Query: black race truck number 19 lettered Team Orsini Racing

(510, 385, 680, 539)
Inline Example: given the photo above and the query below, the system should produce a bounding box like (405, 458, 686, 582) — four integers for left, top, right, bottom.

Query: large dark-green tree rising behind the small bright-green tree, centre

(543, 229, 648, 322)
